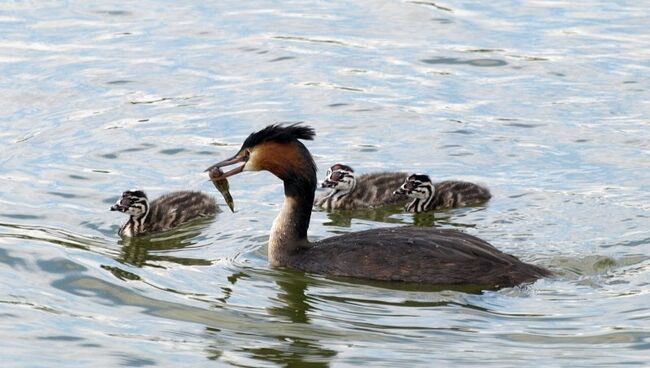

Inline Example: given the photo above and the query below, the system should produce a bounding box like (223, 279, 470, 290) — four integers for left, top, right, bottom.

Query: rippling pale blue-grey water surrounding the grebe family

(0, 0, 650, 367)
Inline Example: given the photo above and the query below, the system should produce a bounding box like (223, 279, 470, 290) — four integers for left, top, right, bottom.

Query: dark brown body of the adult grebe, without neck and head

(294, 227, 547, 286)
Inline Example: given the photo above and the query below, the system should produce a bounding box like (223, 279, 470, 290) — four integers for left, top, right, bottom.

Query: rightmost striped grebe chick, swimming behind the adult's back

(395, 174, 492, 212)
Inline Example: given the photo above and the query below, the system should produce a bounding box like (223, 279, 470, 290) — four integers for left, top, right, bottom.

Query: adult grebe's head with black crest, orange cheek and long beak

(206, 123, 316, 186)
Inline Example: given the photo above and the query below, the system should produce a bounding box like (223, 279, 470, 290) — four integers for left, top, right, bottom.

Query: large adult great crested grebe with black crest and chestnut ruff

(206, 124, 550, 287)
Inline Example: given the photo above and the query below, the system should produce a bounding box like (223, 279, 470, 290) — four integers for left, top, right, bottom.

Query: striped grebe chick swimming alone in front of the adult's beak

(111, 190, 219, 237)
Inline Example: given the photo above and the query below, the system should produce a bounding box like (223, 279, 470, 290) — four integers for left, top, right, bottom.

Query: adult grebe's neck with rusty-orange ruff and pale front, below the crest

(249, 141, 317, 266)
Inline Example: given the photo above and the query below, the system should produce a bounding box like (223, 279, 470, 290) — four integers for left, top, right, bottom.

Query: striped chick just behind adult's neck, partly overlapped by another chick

(314, 164, 408, 210)
